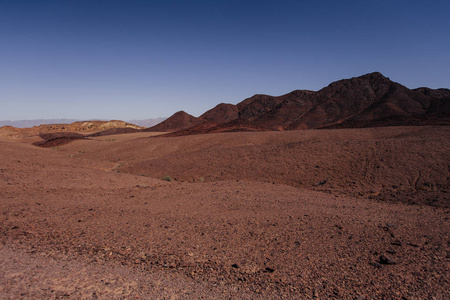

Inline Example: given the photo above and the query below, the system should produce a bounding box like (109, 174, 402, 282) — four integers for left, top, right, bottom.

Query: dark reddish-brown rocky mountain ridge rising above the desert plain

(145, 72, 450, 135)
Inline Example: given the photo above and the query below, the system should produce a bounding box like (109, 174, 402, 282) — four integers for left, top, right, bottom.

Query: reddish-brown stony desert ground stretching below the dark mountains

(0, 126, 450, 299)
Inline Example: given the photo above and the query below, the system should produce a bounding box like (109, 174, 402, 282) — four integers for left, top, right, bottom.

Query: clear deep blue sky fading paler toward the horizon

(0, 0, 450, 120)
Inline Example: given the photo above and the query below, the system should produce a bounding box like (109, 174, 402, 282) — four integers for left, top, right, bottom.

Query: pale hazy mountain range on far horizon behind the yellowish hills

(0, 118, 166, 128)
